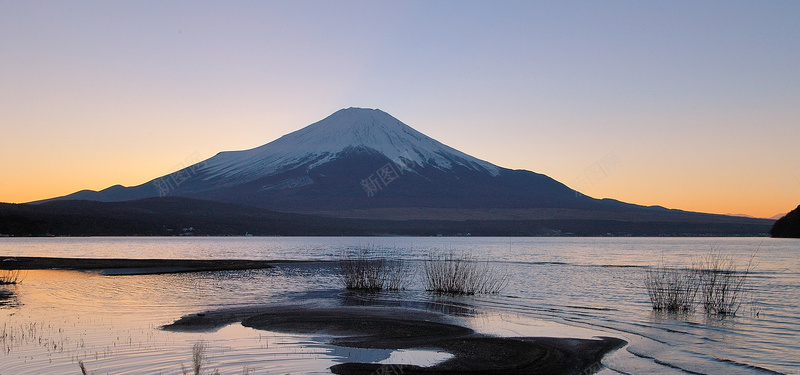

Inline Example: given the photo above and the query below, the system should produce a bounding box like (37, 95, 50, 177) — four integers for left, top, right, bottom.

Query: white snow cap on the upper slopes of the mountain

(200, 108, 500, 180)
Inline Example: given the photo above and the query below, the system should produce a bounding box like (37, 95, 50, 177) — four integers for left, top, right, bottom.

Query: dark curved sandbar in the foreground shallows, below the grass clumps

(162, 305, 627, 375)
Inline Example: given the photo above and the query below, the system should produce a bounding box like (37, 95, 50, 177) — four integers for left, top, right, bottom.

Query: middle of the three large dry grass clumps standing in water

(425, 253, 508, 295)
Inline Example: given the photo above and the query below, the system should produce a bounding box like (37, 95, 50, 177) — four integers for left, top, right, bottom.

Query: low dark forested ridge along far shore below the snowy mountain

(0, 197, 771, 237)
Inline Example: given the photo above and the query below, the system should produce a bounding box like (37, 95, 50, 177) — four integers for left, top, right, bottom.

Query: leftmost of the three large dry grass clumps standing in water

(339, 249, 410, 292)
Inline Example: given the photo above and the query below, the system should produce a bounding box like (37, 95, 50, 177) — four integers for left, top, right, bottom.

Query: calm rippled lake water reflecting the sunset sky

(0, 237, 800, 375)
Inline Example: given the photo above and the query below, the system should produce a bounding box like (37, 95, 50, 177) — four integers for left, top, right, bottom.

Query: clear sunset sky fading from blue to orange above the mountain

(0, 0, 800, 217)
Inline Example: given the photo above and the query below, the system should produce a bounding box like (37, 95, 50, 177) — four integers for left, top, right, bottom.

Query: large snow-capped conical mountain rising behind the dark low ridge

(40, 104, 776, 231)
